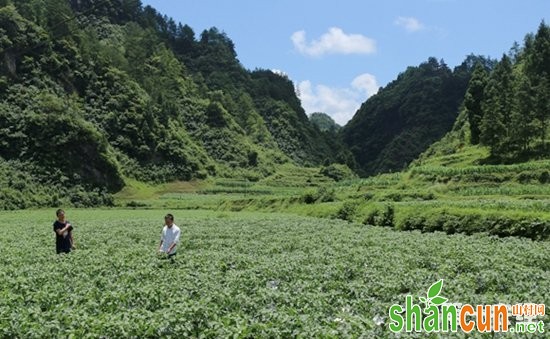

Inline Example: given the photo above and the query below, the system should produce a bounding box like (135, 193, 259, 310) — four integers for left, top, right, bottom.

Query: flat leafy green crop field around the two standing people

(0, 210, 550, 338)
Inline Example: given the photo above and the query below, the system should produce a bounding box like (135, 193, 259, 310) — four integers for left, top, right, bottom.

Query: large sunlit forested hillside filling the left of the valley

(0, 0, 336, 207)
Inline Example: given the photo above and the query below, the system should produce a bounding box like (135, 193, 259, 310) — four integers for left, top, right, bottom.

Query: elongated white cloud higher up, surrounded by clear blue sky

(290, 27, 376, 57)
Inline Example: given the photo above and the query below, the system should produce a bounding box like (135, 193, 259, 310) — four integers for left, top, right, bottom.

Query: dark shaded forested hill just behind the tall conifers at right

(341, 56, 498, 175)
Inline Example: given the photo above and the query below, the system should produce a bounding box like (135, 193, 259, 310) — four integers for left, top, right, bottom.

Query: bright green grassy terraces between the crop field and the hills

(112, 146, 550, 239)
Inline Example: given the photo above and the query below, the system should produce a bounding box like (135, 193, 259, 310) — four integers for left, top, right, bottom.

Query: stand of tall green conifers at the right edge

(464, 21, 550, 161)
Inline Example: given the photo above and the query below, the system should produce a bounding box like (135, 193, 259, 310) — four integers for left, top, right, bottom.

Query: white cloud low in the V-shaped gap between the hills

(298, 73, 378, 126)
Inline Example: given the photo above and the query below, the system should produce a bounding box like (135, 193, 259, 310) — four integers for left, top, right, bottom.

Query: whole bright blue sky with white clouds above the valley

(142, 0, 550, 124)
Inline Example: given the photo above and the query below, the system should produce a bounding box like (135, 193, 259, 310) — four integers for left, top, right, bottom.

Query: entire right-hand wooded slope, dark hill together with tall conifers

(342, 22, 550, 175)
